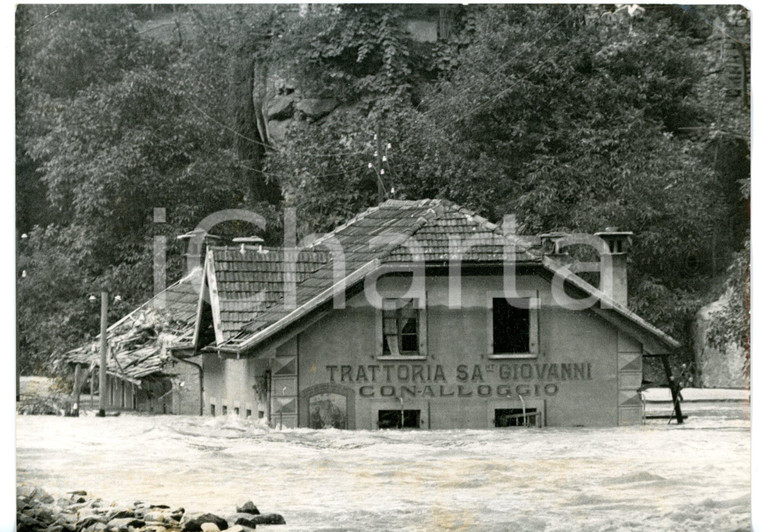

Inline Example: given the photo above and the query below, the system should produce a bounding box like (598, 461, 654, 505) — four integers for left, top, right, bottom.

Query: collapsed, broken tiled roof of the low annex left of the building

(60, 268, 202, 382)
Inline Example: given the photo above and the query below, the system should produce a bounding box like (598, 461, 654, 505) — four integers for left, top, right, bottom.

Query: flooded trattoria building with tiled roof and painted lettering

(192, 200, 679, 429)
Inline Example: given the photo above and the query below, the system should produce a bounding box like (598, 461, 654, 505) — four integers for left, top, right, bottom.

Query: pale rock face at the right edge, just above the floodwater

(693, 294, 749, 388)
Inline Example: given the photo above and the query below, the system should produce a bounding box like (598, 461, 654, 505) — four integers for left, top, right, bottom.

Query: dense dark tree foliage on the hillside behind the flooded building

(16, 5, 749, 371)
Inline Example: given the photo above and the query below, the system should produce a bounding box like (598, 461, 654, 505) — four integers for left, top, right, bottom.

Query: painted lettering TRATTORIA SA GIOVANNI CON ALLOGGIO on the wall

(325, 362, 592, 398)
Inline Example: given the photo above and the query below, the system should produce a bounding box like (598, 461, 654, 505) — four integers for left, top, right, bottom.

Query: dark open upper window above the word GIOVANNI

(488, 297, 538, 358)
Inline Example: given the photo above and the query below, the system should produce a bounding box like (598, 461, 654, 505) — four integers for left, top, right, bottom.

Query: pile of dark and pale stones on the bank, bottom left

(16, 486, 285, 532)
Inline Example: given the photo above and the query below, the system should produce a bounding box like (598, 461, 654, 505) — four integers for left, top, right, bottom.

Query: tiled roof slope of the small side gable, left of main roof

(208, 246, 329, 338)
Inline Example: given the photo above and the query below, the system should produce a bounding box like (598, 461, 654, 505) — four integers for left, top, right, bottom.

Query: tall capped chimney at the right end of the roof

(594, 227, 633, 307)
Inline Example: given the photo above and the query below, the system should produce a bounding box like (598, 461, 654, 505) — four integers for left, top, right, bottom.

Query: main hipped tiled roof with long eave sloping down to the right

(205, 200, 678, 352)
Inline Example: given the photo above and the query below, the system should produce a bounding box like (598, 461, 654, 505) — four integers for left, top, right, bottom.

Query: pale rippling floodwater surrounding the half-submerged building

(16, 403, 750, 532)
